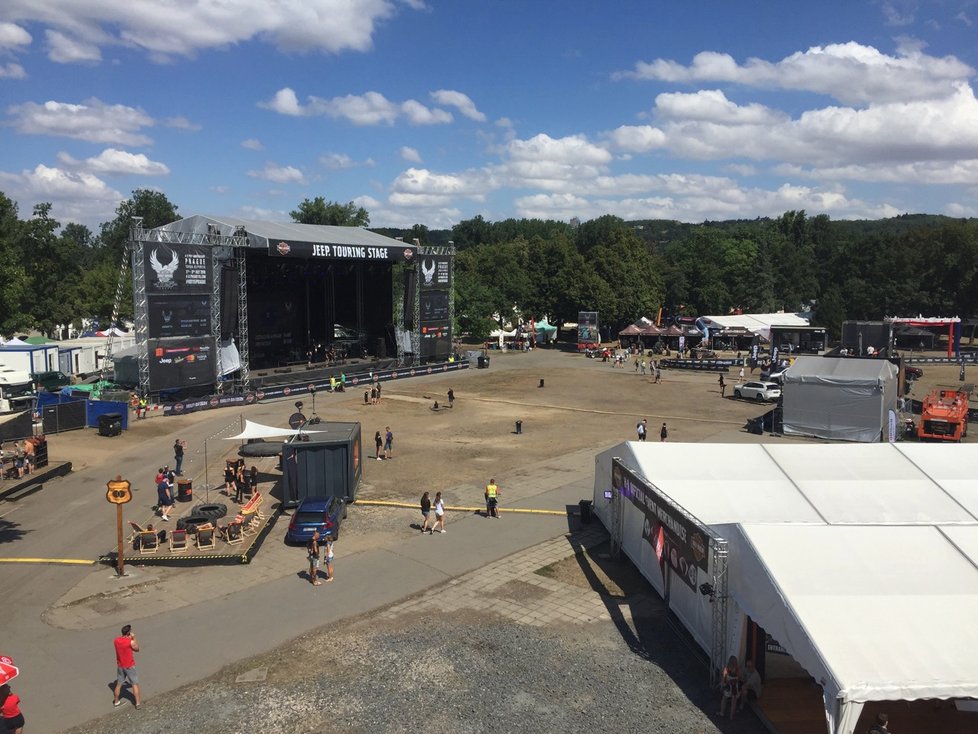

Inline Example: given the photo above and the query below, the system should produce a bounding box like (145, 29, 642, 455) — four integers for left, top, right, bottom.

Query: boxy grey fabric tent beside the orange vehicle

(783, 357, 898, 443)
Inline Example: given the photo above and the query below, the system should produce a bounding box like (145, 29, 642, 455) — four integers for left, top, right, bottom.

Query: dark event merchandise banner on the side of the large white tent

(611, 459, 711, 591)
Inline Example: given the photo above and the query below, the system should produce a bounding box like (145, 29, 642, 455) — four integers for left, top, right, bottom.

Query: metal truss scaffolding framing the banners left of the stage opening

(129, 217, 251, 394)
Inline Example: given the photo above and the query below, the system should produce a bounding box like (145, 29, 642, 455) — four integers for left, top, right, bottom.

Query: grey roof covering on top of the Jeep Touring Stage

(157, 214, 418, 252)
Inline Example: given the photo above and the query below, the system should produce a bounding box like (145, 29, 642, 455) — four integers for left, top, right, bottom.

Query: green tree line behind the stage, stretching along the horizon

(0, 190, 978, 339)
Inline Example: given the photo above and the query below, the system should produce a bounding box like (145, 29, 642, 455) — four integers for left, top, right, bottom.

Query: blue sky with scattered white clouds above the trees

(0, 0, 978, 229)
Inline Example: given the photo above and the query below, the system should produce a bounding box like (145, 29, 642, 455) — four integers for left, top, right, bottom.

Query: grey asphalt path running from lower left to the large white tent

(3, 440, 593, 731)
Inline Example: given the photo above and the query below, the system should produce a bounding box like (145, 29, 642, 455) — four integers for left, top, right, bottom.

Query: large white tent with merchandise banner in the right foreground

(594, 442, 978, 734)
